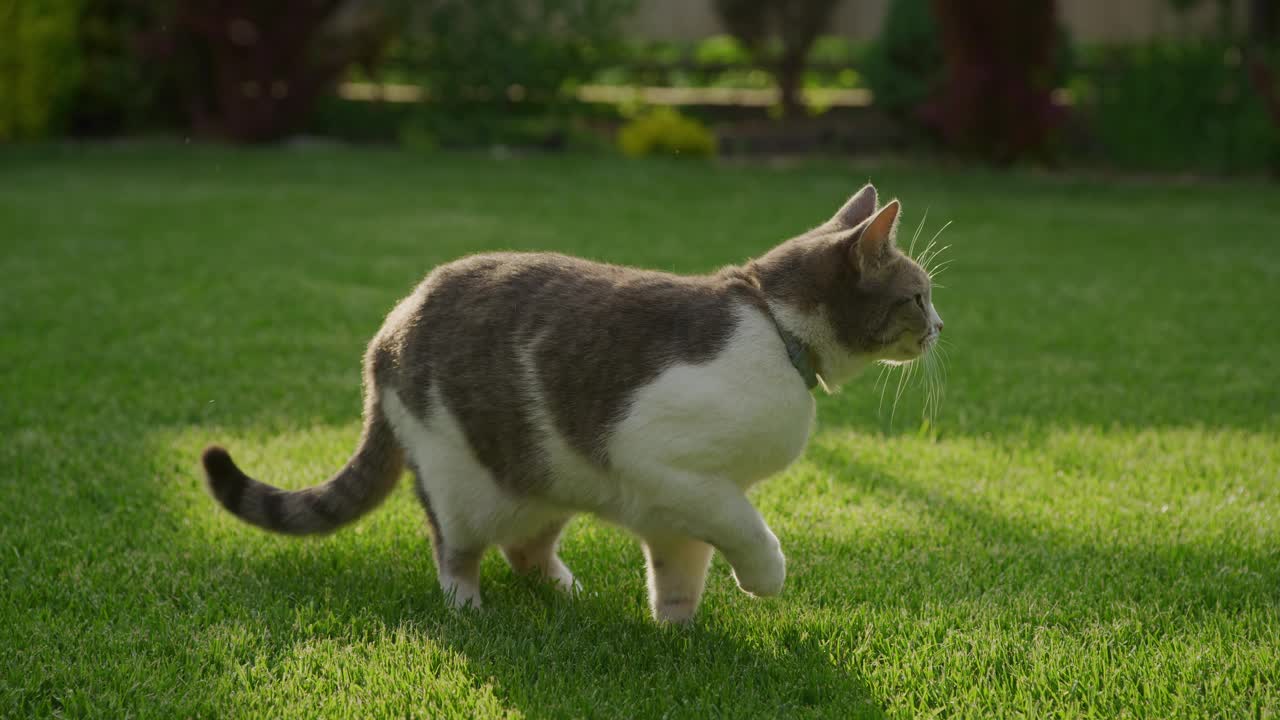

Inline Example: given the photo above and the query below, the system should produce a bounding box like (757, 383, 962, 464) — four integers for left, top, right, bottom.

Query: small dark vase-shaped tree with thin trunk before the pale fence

(716, 0, 841, 118)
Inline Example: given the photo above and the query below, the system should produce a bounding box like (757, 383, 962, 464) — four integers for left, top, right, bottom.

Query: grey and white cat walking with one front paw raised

(202, 184, 942, 623)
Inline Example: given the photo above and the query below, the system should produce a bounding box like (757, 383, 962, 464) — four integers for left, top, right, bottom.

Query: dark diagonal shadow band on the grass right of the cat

(791, 443, 1280, 616)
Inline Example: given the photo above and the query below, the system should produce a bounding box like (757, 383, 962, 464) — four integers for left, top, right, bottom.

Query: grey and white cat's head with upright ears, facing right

(755, 184, 942, 384)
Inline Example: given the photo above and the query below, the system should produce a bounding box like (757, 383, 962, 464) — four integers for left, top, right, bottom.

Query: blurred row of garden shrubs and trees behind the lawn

(0, 0, 1280, 173)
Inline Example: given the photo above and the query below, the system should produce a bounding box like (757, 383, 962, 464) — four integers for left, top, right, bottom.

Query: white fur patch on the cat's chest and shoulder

(609, 306, 814, 487)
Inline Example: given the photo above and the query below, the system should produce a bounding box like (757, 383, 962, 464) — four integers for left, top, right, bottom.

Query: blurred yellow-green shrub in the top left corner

(0, 0, 81, 141)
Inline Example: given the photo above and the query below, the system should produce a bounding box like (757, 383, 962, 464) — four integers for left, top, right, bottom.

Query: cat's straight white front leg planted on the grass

(644, 534, 712, 623)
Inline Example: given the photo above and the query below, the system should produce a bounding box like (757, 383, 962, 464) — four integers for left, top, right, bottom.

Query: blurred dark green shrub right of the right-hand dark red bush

(1079, 42, 1280, 173)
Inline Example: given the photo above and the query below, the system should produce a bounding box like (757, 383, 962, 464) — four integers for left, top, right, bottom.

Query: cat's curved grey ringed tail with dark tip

(201, 398, 404, 536)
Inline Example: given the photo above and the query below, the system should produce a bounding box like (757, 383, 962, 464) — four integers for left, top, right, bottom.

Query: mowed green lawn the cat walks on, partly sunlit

(0, 145, 1280, 717)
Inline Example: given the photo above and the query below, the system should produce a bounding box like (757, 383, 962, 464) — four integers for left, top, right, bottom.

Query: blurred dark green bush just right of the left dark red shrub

(388, 0, 634, 146)
